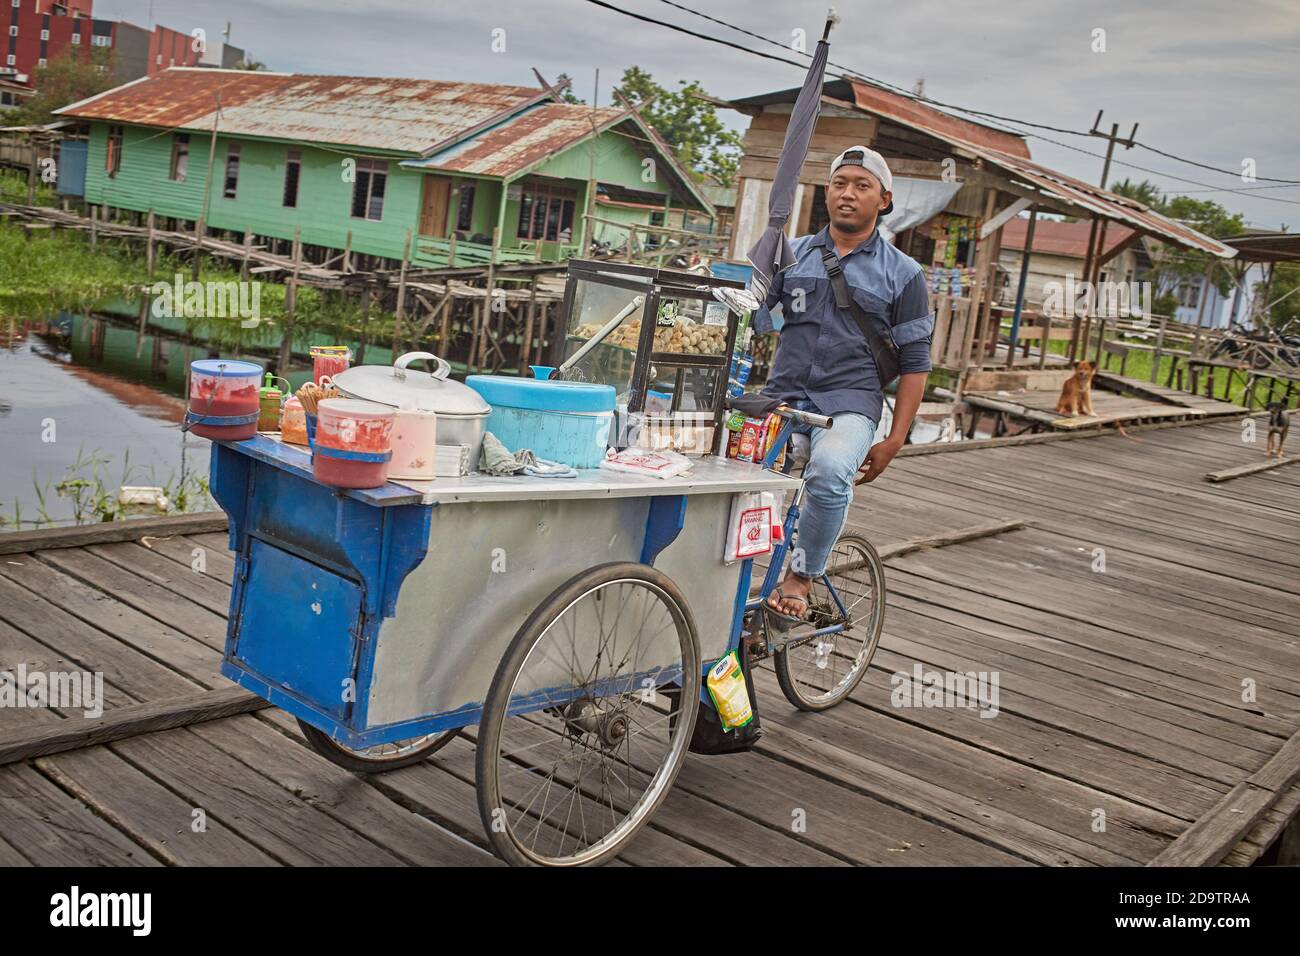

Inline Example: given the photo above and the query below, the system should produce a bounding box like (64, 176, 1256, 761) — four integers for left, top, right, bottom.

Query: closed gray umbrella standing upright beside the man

(749, 10, 836, 302)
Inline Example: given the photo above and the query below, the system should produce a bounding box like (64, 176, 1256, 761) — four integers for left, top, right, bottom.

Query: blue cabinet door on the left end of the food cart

(234, 538, 361, 718)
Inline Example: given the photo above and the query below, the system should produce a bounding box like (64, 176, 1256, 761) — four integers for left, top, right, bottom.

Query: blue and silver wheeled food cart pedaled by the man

(211, 260, 883, 865)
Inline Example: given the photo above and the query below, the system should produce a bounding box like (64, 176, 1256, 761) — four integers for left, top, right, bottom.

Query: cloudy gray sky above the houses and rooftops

(95, 0, 1300, 230)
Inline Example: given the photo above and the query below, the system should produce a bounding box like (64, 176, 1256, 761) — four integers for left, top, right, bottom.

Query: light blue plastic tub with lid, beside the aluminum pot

(465, 375, 615, 468)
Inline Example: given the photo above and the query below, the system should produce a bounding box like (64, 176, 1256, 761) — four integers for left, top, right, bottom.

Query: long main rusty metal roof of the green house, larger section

(57, 68, 545, 153)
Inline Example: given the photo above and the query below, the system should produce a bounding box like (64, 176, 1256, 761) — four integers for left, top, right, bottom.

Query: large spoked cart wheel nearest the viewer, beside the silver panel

(476, 562, 701, 866)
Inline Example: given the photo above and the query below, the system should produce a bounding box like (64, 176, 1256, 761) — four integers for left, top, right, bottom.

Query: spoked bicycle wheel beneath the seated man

(775, 535, 885, 710)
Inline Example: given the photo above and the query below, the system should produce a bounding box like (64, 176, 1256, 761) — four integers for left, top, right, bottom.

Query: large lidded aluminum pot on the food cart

(333, 352, 491, 471)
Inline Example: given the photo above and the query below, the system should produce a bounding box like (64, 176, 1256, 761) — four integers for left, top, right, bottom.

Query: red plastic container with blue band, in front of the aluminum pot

(312, 398, 397, 488)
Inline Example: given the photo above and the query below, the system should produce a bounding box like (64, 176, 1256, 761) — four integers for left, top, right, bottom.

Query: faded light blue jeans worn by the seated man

(793, 399, 876, 578)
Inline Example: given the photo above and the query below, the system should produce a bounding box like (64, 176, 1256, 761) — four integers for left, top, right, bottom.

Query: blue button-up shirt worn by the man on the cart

(754, 226, 935, 424)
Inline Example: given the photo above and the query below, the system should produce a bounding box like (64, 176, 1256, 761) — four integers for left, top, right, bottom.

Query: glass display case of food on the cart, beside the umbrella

(551, 259, 745, 453)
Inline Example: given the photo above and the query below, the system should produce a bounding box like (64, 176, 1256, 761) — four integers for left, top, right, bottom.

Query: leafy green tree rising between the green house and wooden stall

(616, 66, 741, 186)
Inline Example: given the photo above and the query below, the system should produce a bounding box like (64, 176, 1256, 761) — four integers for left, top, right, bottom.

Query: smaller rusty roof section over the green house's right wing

(420, 103, 627, 178)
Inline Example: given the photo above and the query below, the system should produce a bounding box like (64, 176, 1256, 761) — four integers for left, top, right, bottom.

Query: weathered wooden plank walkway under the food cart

(0, 423, 1300, 866)
